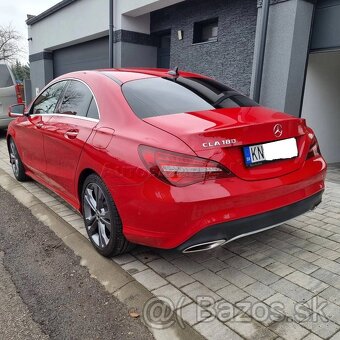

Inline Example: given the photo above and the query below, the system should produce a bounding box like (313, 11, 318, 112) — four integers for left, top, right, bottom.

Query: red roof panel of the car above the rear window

(97, 68, 204, 83)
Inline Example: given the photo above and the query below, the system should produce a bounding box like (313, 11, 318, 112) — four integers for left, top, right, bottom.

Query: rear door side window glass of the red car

(59, 80, 92, 117)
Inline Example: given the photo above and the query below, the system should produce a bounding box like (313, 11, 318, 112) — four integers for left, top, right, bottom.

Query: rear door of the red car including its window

(44, 80, 99, 200)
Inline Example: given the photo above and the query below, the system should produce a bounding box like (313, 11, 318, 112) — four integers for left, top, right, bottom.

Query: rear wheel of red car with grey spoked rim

(81, 174, 134, 257)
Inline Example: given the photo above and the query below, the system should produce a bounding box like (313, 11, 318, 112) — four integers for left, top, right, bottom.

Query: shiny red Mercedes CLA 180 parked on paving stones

(7, 69, 326, 256)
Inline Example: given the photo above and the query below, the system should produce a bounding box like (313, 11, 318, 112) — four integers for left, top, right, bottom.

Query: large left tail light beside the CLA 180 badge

(139, 145, 233, 187)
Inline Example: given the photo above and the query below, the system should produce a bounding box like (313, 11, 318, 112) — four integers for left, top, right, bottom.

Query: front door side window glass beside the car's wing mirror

(31, 81, 66, 114)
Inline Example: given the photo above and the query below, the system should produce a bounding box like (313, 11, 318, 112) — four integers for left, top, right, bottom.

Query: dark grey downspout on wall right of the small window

(253, 0, 270, 102)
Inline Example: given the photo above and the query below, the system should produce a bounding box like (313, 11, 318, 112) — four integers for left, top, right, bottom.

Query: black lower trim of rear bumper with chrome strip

(176, 190, 323, 251)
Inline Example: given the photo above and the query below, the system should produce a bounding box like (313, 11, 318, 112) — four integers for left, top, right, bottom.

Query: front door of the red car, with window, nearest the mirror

(15, 81, 67, 178)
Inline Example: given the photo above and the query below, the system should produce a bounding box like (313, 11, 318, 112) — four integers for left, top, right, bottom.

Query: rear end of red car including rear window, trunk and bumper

(113, 71, 326, 252)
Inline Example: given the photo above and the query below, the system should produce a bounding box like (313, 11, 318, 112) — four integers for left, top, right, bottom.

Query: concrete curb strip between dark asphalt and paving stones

(0, 169, 204, 340)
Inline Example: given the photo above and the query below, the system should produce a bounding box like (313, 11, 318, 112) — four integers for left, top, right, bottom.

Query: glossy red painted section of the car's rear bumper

(111, 157, 326, 249)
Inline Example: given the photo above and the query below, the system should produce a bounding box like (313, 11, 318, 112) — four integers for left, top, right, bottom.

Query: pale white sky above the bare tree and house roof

(0, 0, 61, 63)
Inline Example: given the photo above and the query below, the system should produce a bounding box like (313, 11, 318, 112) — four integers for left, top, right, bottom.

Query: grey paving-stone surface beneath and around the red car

(0, 133, 340, 340)
